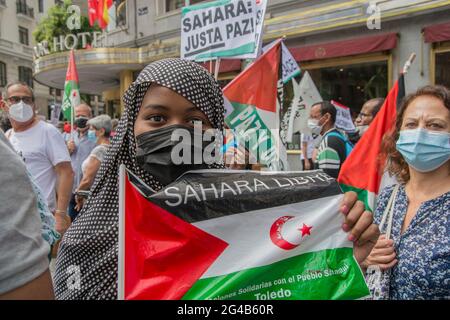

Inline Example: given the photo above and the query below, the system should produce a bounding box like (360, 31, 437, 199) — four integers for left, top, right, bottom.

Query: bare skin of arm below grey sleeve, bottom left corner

(0, 269, 55, 300)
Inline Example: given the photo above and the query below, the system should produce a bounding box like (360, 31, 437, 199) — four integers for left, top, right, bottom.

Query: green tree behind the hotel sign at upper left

(33, 0, 101, 51)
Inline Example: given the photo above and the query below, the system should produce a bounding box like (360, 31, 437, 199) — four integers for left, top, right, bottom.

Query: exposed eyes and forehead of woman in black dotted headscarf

(134, 84, 212, 136)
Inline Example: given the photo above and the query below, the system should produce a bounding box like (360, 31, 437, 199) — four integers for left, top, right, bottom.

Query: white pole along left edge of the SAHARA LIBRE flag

(117, 164, 126, 300)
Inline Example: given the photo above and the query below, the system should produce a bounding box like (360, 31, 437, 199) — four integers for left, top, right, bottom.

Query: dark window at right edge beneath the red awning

(430, 42, 450, 88)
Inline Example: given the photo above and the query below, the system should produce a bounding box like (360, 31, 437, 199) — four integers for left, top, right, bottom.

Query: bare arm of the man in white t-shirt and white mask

(54, 161, 74, 235)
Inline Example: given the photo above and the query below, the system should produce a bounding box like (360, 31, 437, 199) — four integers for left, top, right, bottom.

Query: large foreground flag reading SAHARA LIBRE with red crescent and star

(119, 166, 368, 300)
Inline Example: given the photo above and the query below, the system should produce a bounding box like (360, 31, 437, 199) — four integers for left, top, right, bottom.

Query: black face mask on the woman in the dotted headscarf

(136, 125, 219, 185)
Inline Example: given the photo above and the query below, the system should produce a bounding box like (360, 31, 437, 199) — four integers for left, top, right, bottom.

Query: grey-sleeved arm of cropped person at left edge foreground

(0, 130, 53, 299)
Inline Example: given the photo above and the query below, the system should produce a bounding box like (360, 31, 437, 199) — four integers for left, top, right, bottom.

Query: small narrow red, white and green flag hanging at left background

(61, 50, 81, 121)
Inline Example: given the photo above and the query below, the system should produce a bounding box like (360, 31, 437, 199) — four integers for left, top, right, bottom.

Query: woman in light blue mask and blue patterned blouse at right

(364, 86, 450, 299)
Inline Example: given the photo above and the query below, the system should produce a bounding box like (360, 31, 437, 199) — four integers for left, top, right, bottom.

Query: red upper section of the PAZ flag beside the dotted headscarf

(223, 40, 281, 112)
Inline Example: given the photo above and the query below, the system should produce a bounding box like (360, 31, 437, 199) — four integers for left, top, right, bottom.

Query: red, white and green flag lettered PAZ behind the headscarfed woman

(223, 40, 289, 171)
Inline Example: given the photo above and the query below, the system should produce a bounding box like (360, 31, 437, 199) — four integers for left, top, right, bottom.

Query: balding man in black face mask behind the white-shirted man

(65, 103, 95, 221)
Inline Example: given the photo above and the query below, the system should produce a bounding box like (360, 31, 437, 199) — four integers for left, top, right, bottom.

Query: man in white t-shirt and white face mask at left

(1, 82, 73, 235)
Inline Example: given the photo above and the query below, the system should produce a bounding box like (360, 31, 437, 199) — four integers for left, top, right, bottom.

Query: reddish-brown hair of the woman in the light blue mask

(380, 86, 450, 183)
